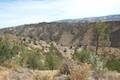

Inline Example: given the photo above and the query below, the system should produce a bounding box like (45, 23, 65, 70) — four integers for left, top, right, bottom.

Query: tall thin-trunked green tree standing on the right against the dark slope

(92, 21, 111, 54)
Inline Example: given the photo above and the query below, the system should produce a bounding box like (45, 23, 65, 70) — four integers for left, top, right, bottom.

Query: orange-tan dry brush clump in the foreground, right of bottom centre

(69, 64, 91, 80)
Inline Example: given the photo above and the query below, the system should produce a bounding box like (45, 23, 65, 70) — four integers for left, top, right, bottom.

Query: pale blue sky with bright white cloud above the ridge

(0, 0, 120, 28)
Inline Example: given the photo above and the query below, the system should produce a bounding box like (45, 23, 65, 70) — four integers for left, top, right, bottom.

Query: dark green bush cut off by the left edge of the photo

(0, 40, 19, 63)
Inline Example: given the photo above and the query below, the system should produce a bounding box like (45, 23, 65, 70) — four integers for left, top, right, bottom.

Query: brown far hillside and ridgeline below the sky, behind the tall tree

(0, 15, 120, 47)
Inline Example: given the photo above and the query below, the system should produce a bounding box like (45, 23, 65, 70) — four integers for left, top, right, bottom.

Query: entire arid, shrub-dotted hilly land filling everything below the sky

(0, 16, 120, 80)
